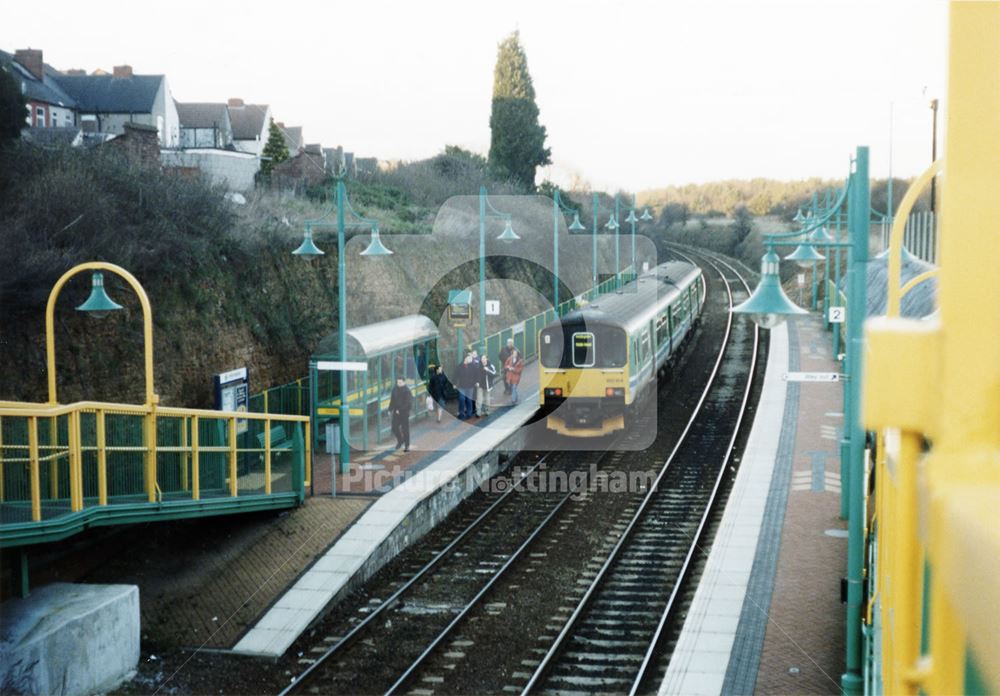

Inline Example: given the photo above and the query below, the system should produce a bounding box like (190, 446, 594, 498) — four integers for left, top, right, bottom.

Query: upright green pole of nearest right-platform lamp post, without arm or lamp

(840, 146, 871, 694)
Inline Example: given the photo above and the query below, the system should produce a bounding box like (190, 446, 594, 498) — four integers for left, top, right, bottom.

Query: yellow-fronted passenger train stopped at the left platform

(538, 260, 706, 438)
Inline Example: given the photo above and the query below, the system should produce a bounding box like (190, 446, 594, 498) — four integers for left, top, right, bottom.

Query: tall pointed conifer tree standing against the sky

(489, 31, 552, 190)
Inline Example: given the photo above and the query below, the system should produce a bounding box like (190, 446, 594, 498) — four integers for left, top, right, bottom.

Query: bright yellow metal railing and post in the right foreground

(863, 2, 1000, 694)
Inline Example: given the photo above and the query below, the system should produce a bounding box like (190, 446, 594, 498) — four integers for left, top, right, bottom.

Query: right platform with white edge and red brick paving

(659, 317, 847, 694)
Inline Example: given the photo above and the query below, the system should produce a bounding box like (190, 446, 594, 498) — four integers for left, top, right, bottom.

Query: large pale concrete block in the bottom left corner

(0, 583, 140, 696)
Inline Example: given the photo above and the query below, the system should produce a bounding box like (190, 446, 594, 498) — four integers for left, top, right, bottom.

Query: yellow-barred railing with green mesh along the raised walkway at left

(0, 401, 311, 522)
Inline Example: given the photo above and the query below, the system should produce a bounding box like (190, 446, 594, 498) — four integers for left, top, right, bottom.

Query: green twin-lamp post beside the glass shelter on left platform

(292, 179, 392, 474)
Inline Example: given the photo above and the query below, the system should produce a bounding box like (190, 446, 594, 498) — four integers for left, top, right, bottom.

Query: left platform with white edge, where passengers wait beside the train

(233, 370, 538, 657)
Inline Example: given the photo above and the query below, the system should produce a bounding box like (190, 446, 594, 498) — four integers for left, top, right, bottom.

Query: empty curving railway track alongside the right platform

(521, 250, 759, 695)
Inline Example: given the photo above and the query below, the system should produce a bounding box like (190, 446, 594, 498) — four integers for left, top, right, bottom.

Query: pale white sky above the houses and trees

(0, 0, 947, 191)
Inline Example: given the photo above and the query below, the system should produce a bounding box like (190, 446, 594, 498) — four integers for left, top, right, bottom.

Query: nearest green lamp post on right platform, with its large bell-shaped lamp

(732, 147, 871, 694)
